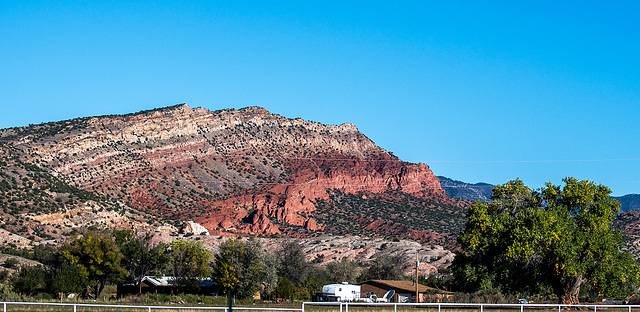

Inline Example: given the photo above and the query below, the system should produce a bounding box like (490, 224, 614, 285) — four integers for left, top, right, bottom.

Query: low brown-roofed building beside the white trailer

(359, 280, 441, 302)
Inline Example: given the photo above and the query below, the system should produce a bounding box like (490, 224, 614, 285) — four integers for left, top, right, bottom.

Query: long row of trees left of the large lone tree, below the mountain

(0, 230, 403, 300)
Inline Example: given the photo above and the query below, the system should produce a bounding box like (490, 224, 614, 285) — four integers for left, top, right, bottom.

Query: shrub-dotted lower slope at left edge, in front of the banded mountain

(0, 144, 171, 247)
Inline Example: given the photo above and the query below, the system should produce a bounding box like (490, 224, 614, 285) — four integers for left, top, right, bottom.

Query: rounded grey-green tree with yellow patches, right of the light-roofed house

(213, 239, 278, 299)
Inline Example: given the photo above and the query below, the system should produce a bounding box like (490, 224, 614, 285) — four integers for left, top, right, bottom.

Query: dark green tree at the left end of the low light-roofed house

(113, 230, 168, 293)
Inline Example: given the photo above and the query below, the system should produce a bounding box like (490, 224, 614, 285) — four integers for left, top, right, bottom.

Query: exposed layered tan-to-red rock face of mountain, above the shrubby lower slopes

(0, 105, 446, 239)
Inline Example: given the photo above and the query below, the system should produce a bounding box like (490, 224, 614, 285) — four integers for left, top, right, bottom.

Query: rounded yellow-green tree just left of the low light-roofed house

(60, 232, 127, 299)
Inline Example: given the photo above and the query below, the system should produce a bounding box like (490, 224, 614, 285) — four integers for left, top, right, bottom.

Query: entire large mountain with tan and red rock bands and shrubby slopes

(0, 104, 466, 243)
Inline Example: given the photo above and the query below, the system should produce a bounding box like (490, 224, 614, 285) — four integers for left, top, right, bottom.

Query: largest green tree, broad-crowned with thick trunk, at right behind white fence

(453, 178, 640, 304)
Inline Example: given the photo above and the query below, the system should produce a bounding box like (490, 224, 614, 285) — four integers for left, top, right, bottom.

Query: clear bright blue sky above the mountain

(0, 1, 640, 195)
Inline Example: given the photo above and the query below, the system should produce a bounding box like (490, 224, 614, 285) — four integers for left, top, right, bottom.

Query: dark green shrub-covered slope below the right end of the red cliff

(315, 190, 466, 248)
